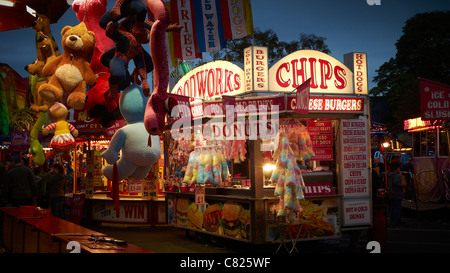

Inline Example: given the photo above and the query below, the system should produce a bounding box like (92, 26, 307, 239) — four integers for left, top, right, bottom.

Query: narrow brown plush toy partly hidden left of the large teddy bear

(25, 31, 56, 112)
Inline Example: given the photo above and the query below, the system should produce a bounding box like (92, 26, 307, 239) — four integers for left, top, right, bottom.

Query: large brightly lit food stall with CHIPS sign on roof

(164, 47, 372, 244)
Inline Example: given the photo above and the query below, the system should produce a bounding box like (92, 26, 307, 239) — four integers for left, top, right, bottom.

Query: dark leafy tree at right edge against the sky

(370, 11, 450, 132)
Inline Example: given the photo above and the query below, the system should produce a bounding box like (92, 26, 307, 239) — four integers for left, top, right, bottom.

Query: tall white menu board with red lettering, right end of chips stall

(341, 119, 369, 197)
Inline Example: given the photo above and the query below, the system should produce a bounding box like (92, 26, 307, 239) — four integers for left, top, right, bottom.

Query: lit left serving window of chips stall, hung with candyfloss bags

(165, 132, 251, 192)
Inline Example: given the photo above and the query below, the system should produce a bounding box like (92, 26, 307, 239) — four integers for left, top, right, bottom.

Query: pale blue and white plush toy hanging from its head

(101, 83, 161, 181)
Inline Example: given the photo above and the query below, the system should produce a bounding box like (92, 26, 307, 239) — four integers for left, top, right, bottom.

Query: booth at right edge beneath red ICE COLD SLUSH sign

(404, 78, 450, 204)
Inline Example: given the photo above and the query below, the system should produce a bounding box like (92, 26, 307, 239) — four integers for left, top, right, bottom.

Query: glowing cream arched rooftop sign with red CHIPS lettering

(171, 47, 367, 99)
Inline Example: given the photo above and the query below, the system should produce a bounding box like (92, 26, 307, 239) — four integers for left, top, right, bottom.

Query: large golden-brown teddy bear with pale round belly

(38, 22, 96, 110)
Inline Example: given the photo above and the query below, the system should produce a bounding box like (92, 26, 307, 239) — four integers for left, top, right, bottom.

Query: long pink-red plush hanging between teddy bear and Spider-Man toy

(72, 0, 122, 127)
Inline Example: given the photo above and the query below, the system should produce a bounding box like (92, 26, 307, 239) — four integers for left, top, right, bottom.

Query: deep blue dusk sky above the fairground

(0, 0, 450, 88)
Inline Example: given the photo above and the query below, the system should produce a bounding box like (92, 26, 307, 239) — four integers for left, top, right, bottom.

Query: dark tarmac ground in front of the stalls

(81, 202, 450, 253)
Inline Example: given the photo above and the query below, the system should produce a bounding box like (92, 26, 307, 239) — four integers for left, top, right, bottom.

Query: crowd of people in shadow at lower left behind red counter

(0, 156, 67, 218)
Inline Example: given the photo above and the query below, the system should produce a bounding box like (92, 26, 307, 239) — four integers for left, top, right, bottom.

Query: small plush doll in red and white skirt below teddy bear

(42, 102, 78, 161)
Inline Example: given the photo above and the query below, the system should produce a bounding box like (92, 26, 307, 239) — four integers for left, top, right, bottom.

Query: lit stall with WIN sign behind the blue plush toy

(66, 109, 165, 225)
